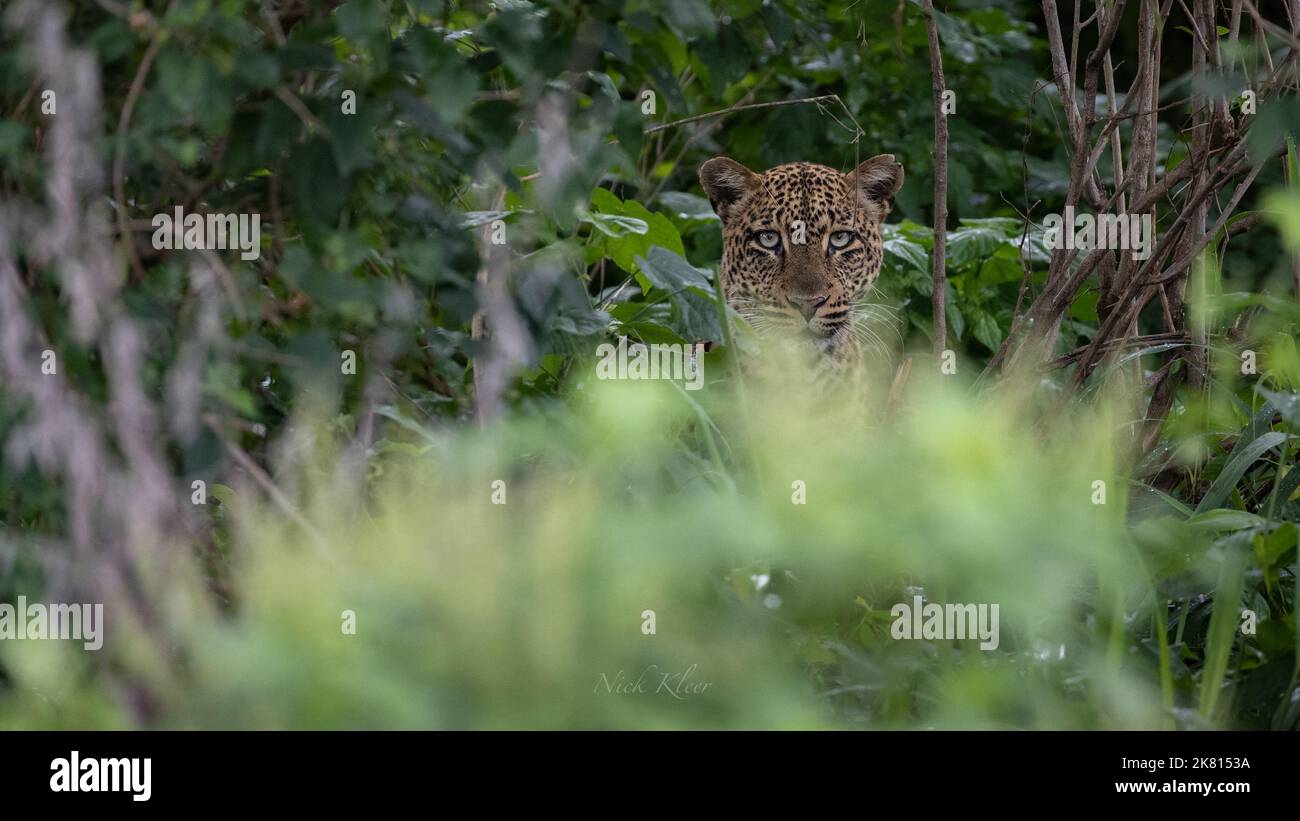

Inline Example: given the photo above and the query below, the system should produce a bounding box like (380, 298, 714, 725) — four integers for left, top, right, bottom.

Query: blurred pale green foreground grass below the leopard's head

(0, 366, 1167, 727)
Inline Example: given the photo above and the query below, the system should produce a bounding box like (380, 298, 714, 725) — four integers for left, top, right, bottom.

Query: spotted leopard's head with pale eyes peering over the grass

(699, 155, 904, 362)
